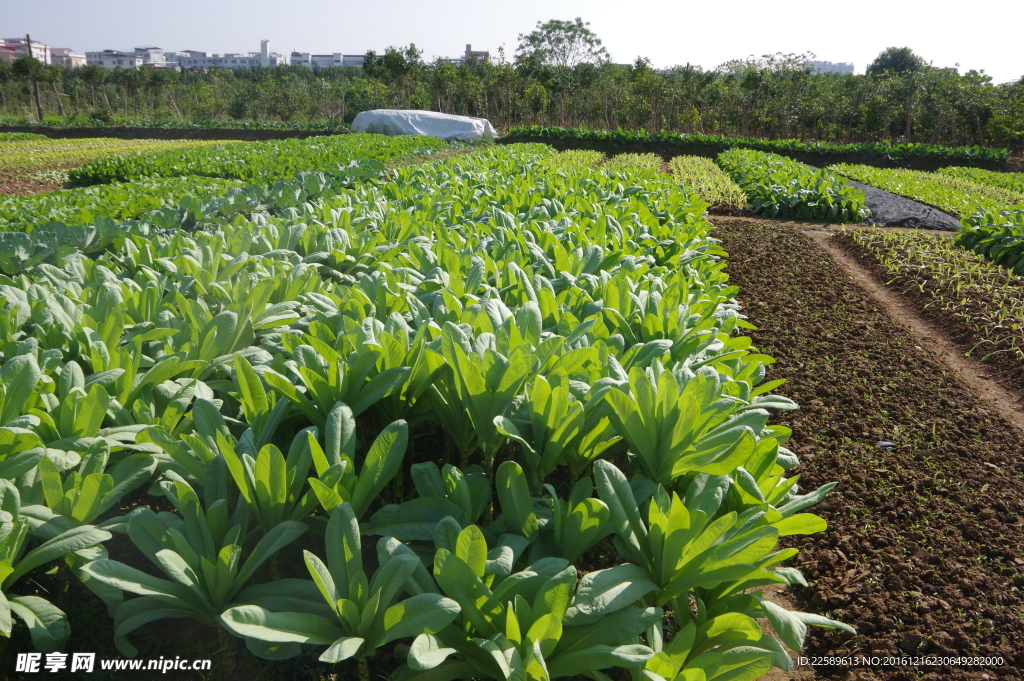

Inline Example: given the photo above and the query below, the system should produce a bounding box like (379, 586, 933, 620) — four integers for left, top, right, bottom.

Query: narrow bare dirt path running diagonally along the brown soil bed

(804, 231, 1024, 434)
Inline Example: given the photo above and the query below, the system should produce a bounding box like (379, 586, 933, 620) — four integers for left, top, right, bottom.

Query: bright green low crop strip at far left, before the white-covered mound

(64, 134, 447, 185)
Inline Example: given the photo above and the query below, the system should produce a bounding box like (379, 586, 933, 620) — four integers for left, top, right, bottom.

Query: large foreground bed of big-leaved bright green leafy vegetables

(0, 145, 849, 681)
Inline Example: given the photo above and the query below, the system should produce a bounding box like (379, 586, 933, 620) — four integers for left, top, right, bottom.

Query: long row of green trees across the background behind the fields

(0, 19, 1024, 150)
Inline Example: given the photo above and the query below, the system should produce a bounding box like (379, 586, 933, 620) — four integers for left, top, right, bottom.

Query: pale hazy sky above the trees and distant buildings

(8, 0, 1024, 83)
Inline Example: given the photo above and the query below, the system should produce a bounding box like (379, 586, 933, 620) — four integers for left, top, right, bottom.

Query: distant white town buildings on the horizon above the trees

(0, 37, 490, 71)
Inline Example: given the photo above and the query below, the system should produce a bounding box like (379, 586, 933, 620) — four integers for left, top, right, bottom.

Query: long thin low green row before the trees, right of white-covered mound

(508, 126, 1010, 163)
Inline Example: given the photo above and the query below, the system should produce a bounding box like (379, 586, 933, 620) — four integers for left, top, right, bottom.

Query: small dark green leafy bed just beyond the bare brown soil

(718, 150, 870, 223)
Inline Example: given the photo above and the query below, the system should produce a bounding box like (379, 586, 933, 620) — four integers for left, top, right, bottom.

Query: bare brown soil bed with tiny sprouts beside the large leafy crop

(715, 218, 1024, 681)
